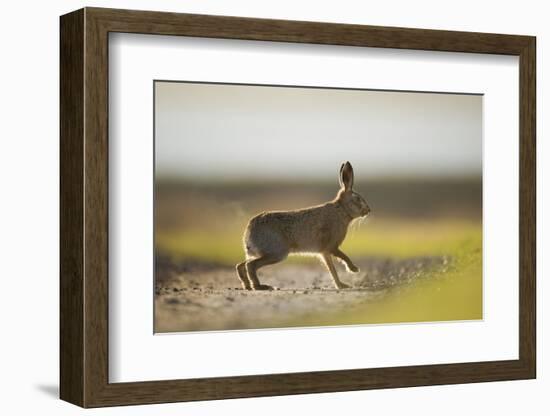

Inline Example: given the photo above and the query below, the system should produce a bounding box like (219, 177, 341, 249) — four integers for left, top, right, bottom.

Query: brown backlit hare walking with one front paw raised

(236, 162, 371, 290)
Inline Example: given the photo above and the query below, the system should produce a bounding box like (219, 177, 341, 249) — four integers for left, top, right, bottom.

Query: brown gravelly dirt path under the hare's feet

(155, 257, 448, 332)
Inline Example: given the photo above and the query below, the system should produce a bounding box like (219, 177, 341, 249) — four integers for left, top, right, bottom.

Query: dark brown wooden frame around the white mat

(60, 8, 536, 407)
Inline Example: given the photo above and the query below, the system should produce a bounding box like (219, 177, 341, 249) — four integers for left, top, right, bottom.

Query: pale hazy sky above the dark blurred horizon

(155, 81, 483, 181)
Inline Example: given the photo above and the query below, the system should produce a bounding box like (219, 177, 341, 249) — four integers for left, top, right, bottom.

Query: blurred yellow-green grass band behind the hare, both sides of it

(156, 220, 481, 265)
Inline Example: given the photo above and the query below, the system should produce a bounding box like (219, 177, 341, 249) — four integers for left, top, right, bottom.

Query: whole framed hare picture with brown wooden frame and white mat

(60, 8, 536, 407)
